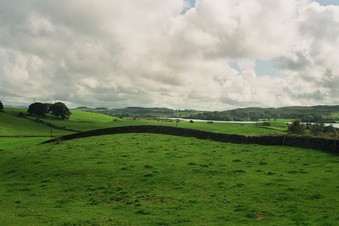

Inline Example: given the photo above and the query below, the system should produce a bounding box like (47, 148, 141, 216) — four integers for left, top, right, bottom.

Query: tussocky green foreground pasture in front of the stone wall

(0, 134, 339, 225)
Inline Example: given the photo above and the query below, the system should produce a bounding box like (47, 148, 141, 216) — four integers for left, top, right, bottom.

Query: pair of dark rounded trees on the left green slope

(27, 102, 71, 120)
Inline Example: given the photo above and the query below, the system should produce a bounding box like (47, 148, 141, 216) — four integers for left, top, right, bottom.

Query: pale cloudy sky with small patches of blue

(0, 0, 339, 110)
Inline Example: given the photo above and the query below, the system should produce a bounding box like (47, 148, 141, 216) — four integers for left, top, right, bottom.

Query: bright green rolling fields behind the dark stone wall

(0, 108, 286, 149)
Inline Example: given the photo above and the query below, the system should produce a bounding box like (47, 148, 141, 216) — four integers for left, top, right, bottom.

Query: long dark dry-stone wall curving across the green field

(44, 125, 339, 154)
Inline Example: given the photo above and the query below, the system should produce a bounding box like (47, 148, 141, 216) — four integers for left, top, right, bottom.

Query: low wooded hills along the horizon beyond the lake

(79, 105, 339, 122)
